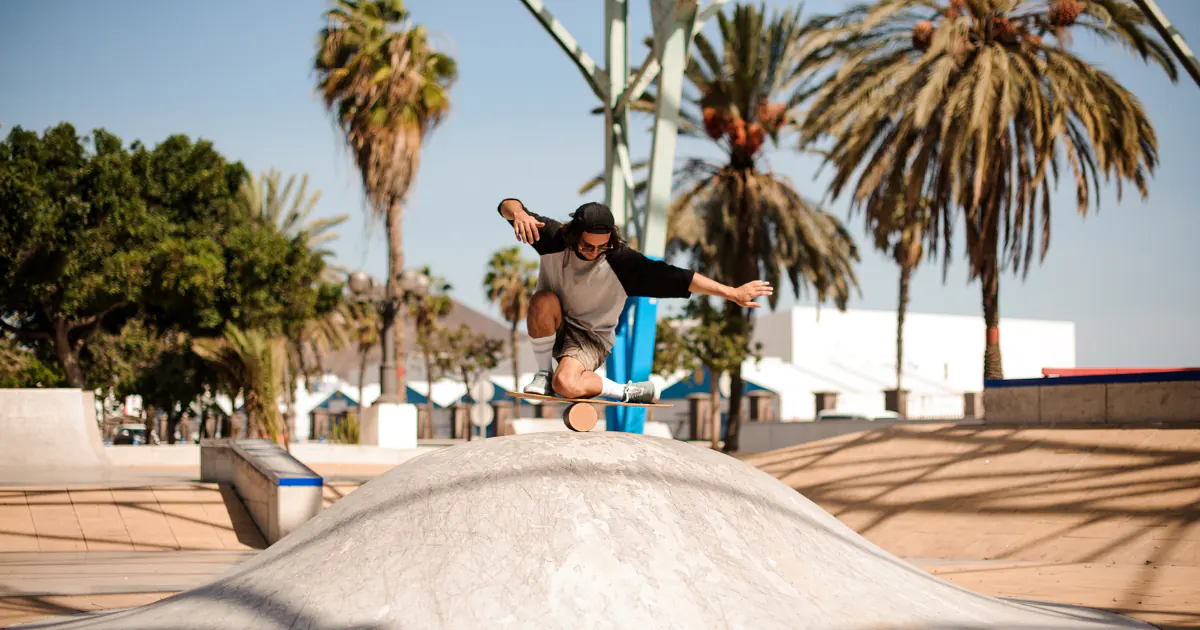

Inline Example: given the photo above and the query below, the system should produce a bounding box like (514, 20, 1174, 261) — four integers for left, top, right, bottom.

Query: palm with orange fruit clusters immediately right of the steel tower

(584, 5, 859, 450)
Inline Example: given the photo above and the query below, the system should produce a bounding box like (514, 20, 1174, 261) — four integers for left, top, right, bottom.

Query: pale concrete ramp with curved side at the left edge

(0, 389, 110, 469)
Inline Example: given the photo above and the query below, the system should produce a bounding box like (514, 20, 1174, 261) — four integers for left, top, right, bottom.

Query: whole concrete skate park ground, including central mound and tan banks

(0, 376, 1200, 628)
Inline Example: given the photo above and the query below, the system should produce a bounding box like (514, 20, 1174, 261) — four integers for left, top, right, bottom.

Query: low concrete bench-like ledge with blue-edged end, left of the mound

(200, 438, 324, 545)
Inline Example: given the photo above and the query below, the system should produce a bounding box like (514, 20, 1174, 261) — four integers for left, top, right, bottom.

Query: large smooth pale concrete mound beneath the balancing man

(22, 432, 1147, 630)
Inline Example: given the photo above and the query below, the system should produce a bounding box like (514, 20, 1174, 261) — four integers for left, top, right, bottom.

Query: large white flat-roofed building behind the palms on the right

(743, 307, 1075, 420)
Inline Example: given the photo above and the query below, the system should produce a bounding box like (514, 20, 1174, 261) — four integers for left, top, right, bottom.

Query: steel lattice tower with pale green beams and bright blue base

(521, 0, 727, 433)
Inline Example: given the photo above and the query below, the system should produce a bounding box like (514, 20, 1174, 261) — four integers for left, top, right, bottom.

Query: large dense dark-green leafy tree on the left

(0, 124, 342, 446)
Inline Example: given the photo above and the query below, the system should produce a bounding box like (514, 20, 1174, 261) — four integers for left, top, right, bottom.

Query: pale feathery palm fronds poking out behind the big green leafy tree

(238, 168, 349, 282)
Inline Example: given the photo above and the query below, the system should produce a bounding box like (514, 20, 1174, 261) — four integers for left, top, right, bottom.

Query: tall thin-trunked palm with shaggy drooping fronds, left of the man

(313, 0, 458, 400)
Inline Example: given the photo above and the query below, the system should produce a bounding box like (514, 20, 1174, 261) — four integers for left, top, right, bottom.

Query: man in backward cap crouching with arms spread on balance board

(497, 198, 772, 403)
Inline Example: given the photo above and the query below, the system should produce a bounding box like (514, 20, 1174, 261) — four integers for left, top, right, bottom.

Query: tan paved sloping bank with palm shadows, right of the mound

(742, 425, 1200, 628)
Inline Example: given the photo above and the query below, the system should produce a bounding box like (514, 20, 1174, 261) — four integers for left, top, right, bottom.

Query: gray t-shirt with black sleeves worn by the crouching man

(497, 202, 695, 349)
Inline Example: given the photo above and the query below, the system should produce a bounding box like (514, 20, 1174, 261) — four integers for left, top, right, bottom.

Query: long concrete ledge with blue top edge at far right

(984, 370, 1200, 425)
